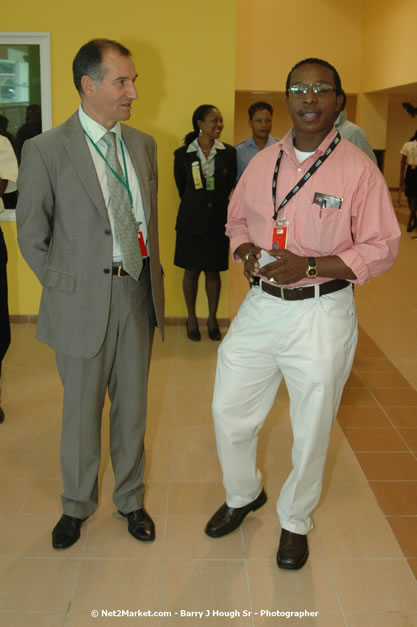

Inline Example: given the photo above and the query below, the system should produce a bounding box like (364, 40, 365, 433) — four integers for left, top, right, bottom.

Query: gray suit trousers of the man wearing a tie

(56, 267, 156, 518)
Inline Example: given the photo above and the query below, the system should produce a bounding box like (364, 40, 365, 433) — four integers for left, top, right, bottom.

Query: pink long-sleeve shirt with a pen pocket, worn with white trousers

(226, 129, 401, 286)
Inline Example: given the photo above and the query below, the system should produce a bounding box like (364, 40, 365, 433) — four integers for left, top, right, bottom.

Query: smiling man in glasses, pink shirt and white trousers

(206, 59, 400, 570)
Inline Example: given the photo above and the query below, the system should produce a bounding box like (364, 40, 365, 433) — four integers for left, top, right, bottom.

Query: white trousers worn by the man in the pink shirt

(213, 285, 358, 534)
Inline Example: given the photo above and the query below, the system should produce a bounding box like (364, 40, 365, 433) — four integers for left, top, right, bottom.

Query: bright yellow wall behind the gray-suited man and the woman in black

(1, 0, 236, 317)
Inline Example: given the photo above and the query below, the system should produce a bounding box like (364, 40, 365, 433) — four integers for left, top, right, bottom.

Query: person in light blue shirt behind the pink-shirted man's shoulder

(236, 100, 278, 180)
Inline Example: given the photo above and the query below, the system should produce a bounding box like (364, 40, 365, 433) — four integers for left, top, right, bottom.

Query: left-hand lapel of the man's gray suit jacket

(64, 112, 108, 221)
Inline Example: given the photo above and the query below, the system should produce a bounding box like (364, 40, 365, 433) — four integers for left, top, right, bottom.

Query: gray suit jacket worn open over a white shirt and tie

(16, 113, 164, 357)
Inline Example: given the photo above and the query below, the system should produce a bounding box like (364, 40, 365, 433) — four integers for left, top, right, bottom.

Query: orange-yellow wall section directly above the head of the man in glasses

(236, 0, 363, 93)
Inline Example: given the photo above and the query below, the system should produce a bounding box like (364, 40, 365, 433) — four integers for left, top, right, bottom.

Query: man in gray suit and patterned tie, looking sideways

(16, 39, 164, 549)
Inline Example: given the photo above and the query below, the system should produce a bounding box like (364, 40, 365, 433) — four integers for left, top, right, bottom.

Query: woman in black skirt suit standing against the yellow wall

(174, 105, 236, 341)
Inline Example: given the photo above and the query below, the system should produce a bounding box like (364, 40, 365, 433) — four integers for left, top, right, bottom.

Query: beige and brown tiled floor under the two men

(0, 220, 417, 627)
